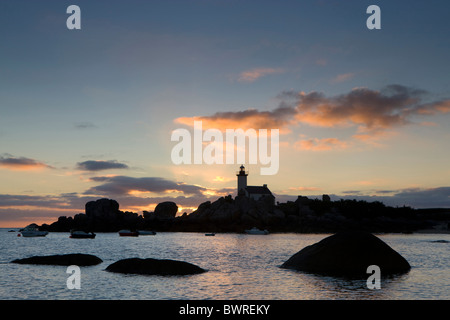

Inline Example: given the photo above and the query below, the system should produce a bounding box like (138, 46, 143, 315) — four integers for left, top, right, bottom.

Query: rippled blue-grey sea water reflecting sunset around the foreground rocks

(0, 229, 450, 300)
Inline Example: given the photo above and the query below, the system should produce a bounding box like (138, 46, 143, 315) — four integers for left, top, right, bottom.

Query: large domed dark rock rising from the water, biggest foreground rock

(281, 231, 411, 277)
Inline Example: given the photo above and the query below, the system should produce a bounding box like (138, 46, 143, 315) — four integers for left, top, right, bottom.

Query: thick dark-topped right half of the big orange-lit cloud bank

(282, 85, 450, 132)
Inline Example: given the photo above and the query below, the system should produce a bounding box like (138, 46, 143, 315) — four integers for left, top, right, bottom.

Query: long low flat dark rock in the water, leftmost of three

(11, 253, 103, 266)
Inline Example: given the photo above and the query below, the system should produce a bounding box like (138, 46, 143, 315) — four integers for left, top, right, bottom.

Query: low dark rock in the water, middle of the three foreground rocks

(106, 258, 206, 276)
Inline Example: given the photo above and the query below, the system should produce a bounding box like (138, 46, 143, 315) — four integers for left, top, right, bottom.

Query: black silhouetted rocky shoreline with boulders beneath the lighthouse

(40, 195, 450, 233)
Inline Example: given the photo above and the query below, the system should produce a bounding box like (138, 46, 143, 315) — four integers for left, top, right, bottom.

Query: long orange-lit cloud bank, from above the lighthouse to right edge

(175, 84, 450, 141)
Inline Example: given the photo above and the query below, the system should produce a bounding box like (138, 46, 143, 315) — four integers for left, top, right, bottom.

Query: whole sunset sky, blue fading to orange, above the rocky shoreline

(0, 0, 450, 227)
